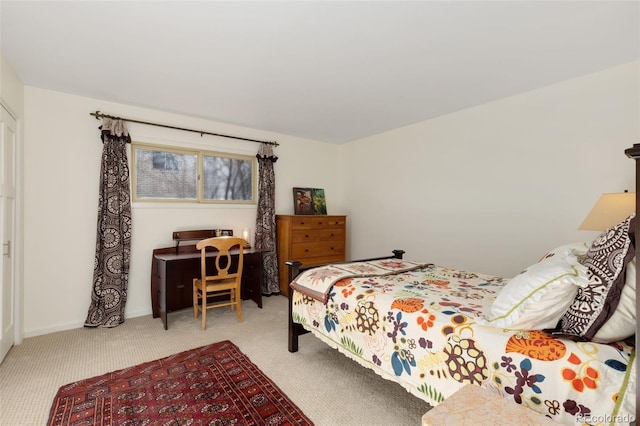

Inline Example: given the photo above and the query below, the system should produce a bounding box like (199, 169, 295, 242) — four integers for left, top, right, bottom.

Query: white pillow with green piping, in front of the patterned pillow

(478, 250, 589, 330)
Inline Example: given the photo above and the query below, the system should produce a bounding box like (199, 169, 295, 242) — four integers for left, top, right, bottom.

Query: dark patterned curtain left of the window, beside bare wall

(84, 118, 131, 327)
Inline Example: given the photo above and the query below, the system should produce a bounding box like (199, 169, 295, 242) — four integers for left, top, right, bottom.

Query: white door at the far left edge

(0, 105, 17, 362)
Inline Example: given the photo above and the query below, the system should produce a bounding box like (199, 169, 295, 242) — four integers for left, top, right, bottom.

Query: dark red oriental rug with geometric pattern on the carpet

(48, 341, 313, 426)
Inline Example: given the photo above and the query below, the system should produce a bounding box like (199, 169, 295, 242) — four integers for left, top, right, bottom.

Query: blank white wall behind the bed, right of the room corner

(342, 62, 640, 276)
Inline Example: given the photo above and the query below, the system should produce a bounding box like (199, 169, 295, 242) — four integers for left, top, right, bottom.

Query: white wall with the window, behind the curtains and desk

(24, 86, 341, 336)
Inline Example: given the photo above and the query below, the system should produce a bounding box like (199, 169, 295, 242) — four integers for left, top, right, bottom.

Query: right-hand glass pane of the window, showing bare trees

(202, 156, 252, 201)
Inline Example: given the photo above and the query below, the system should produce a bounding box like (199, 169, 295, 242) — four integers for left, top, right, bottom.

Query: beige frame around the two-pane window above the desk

(131, 141, 258, 205)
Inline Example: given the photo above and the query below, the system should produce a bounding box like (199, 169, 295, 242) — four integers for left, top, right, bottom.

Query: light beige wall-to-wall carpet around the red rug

(0, 296, 430, 426)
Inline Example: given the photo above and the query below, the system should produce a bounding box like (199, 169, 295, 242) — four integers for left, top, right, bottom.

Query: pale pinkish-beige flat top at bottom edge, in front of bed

(422, 385, 558, 426)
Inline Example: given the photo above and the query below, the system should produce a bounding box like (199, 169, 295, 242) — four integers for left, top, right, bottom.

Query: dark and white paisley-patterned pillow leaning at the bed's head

(558, 213, 635, 340)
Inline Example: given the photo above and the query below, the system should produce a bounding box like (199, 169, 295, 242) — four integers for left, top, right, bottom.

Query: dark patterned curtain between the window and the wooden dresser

(255, 143, 280, 294)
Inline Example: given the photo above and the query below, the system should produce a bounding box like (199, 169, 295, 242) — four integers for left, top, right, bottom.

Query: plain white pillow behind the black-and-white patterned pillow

(592, 257, 636, 343)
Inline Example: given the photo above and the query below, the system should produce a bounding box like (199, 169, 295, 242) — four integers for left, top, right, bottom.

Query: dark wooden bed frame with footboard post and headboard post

(285, 143, 640, 356)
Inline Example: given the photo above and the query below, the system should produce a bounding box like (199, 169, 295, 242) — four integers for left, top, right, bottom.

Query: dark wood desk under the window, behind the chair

(151, 245, 262, 330)
